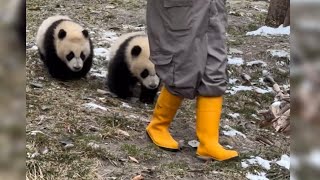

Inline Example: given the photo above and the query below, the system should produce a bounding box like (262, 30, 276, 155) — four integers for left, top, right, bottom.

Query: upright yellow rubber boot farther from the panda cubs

(196, 96, 238, 161)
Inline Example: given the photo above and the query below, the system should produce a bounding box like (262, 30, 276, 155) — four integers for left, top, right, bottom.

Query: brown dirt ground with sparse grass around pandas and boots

(26, 0, 290, 180)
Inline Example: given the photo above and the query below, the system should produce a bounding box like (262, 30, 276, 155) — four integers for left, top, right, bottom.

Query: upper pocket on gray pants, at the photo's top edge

(163, 0, 193, 31)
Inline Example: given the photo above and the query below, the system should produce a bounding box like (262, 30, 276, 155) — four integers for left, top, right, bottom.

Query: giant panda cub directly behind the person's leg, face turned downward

(107, 32, 160, 104)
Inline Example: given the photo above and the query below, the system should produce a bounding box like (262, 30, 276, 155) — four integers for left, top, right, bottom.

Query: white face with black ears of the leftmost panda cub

(55, 25, 90, 72)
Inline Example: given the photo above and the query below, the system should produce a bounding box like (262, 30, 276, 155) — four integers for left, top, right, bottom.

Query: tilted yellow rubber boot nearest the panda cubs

(146, 87, 183, 150)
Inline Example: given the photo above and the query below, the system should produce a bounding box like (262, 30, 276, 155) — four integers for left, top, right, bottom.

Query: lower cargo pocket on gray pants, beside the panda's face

(151, 54, 174, 86)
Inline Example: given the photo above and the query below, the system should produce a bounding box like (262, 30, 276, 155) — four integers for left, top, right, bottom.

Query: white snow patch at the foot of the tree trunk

(246, 25, 290, 36)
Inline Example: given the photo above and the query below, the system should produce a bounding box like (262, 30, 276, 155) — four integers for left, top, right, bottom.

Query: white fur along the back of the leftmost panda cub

(36, 15, 71, 54)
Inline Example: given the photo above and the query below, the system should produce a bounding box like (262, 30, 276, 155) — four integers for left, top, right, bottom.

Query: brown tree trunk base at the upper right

(266, 0, 290, 27)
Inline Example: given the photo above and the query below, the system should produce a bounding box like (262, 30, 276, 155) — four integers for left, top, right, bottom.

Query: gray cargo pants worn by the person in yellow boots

(147, 0, 227, 99)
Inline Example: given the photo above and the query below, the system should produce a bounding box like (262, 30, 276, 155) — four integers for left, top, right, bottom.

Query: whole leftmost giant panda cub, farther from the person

(36, 15, 93, 80)
